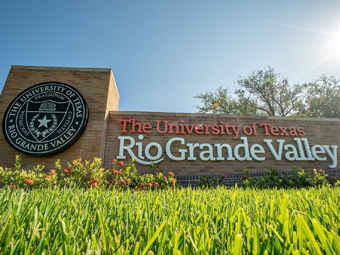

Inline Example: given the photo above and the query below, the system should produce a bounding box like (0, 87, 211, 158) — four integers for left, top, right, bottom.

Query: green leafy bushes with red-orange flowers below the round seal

(0, 156, 176, 190)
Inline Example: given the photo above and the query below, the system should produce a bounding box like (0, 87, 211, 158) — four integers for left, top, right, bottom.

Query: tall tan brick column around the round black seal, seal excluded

(0, 66, 119, 169)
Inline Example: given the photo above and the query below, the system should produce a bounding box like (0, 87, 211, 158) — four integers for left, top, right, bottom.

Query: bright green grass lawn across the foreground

(0, 188, 340, 255)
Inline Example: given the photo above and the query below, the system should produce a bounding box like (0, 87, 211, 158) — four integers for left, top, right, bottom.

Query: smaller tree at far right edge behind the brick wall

(299, 75, 340, 118)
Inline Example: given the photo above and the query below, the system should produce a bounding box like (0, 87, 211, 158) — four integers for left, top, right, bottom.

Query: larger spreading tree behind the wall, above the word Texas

(194, 66, 304, 116)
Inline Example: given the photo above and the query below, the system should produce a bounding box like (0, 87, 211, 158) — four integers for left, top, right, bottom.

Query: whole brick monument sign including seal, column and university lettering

(0, 66, 340, 185)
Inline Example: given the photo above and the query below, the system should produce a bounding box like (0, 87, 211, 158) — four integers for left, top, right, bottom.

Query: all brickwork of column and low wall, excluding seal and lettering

(0, 66, 340, 183)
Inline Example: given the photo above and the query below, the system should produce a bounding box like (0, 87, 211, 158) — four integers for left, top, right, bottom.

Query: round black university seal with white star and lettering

(2, 82, 89, 156)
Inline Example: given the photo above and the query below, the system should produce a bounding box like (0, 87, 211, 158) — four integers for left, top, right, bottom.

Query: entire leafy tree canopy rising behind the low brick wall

(194, 66, 340, 118)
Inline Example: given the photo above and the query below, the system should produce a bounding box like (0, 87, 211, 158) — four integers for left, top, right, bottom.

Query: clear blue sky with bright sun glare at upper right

(0, 0, 340, 112)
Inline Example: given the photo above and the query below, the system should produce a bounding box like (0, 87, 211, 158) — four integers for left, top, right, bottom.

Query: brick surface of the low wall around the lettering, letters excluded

(105, 111, 340, 175)
